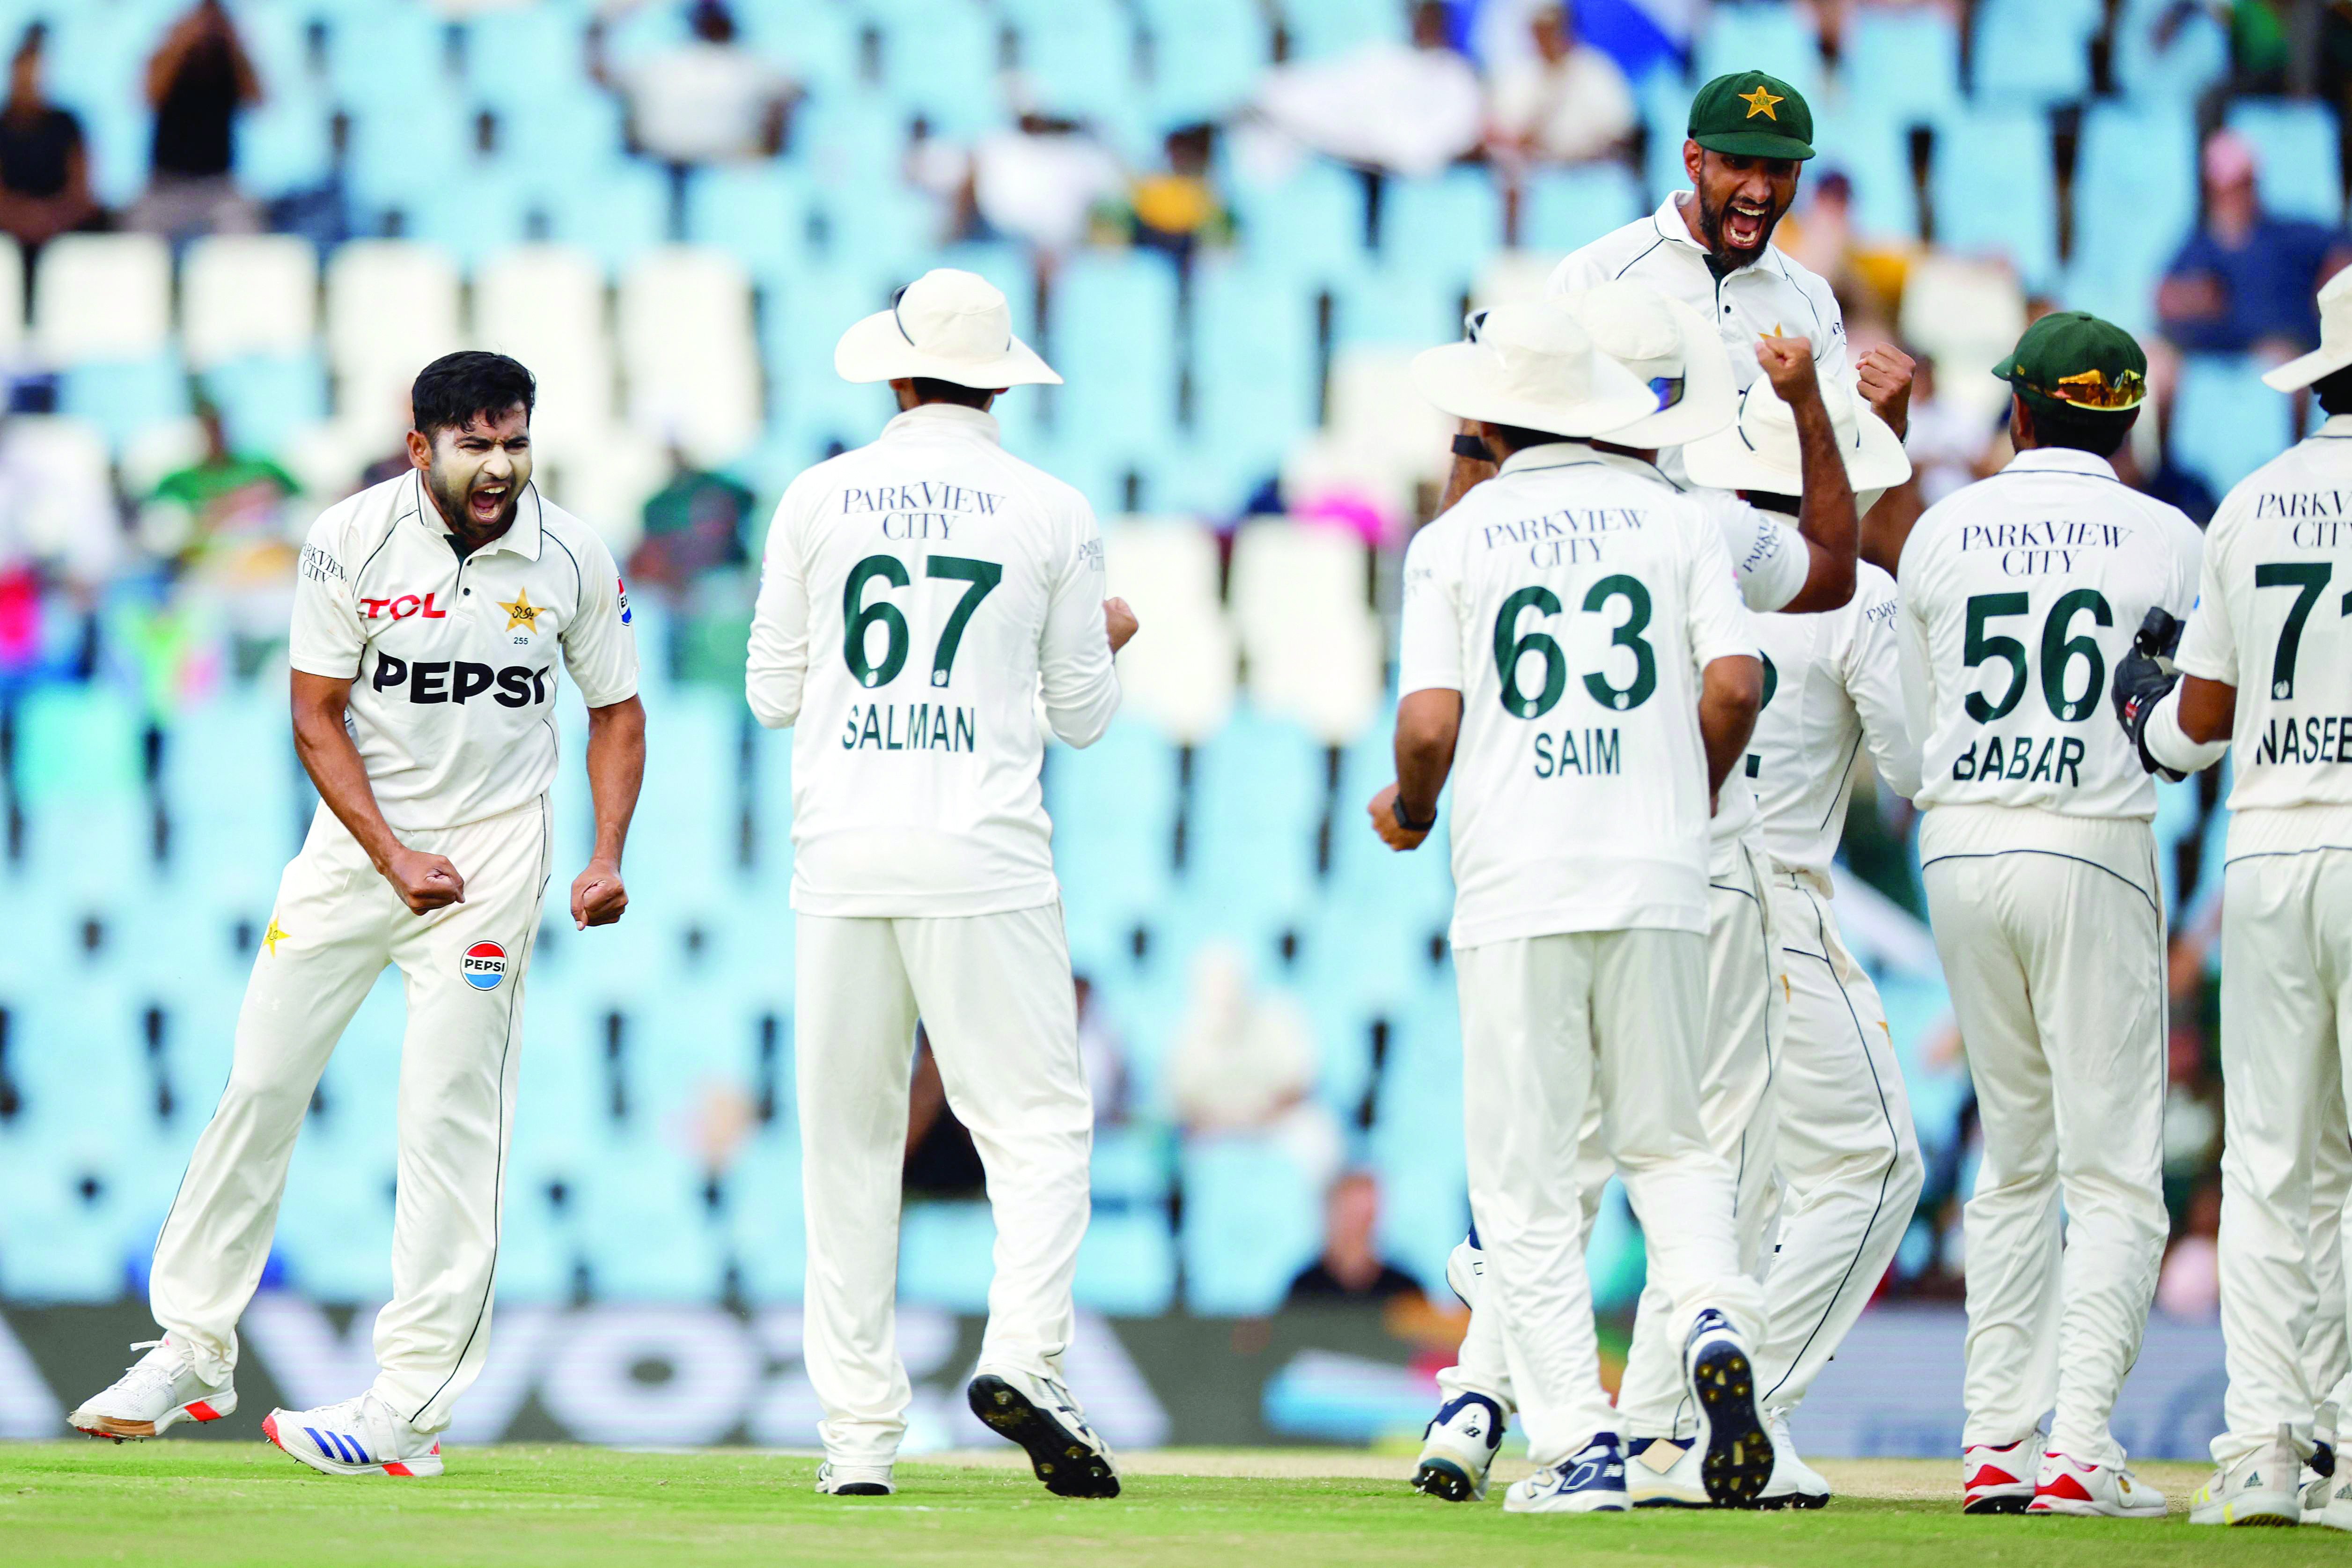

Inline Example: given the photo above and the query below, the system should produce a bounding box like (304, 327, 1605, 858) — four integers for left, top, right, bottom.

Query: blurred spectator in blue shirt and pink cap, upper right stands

(2157, 132, 2352, 360)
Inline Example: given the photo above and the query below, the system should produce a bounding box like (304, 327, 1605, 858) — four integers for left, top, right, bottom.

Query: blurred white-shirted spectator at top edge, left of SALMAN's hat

(588, 0, 800, 169)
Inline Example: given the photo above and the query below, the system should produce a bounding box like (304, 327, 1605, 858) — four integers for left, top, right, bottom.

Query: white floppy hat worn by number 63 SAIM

(1413, 299, 1658, 437)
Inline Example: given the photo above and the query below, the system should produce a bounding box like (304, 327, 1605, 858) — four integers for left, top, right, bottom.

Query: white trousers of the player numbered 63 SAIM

(1454, 931, 1762, 1465)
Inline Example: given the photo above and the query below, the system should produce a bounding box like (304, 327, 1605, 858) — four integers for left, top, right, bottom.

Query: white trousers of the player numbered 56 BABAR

(1919, 806, 2164, 1465)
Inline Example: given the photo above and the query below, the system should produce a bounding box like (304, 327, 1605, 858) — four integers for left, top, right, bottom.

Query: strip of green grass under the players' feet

(0, 1439, 2352, 1568)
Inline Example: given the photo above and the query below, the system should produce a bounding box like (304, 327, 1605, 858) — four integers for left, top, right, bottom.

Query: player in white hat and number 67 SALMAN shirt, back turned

(748, 270, 1136, 1497)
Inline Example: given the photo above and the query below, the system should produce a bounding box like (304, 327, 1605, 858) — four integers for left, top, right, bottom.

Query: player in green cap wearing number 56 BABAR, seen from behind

(1898, 313, 2192, 1519)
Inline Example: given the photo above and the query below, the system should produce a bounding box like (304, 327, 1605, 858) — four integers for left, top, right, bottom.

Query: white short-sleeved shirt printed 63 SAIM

(1399, 442, 1755, 947)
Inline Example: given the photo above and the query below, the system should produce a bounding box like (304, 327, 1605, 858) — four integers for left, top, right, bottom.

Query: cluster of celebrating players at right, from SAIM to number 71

(1371, 73, 2352, 1528)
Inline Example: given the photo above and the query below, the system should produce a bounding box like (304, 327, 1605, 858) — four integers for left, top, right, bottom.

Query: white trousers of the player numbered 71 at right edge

(2213, 846, 2352, 1465)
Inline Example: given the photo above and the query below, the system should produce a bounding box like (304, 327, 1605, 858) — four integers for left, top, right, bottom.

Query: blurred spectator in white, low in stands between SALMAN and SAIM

(1167, 942, 1341, 1185)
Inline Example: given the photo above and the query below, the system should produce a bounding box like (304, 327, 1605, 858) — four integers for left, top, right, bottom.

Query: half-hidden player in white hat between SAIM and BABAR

(1684, 381, 1924, 1507)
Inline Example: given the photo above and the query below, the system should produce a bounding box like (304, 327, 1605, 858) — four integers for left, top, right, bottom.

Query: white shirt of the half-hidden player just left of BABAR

(1743, 562, 1919, 877)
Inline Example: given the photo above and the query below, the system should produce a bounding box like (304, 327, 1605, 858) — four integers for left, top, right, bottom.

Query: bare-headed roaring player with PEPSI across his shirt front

(71, 353, 645, 1476)
